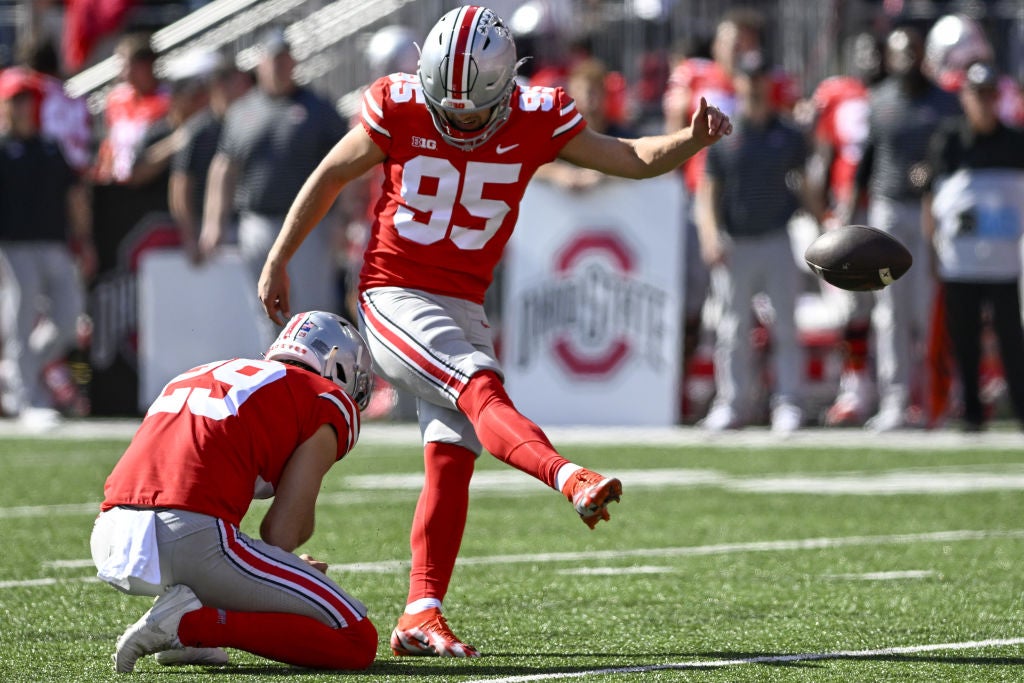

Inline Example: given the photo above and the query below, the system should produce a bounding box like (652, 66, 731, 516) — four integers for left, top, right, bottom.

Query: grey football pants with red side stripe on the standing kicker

(359, 287, 502, 455)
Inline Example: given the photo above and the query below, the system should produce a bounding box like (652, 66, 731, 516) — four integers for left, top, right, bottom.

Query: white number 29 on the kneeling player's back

(145, 358, 286, 420)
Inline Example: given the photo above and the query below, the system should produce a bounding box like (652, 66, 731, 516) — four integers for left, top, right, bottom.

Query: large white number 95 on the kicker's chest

(394, 157, 522, 251)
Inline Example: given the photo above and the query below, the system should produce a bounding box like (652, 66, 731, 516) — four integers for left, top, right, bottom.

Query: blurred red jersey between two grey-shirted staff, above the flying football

(811, 76, 869, 202)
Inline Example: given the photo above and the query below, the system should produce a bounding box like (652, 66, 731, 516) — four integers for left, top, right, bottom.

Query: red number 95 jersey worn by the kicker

(359, 74, 587, 303)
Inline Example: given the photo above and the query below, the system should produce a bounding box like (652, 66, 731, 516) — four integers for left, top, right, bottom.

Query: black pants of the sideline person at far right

(943, 281, 1024, 425)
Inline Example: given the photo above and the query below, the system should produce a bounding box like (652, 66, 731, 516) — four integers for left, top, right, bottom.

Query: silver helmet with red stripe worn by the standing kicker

(419, 5, 519, 151)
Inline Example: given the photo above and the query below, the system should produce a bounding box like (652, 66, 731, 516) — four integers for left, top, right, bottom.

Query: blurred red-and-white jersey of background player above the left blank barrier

(94, 83, 171, 182)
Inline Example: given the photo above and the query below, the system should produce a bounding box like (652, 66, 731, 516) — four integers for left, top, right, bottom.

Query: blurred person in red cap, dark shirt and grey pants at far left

(0, 67, 96, 428)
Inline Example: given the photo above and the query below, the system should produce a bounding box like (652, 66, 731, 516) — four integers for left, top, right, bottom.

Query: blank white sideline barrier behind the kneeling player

(138, 249, 272, 413)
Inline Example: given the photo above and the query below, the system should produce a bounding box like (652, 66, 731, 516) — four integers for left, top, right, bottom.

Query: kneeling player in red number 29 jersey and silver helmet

(91, 311, 377, 673)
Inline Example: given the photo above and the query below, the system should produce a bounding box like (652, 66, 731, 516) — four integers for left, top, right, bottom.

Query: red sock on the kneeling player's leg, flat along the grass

(178, 607, 377, 670)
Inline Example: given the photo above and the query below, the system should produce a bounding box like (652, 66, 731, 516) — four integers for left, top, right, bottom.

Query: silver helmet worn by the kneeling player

(263, 310, 373, 411)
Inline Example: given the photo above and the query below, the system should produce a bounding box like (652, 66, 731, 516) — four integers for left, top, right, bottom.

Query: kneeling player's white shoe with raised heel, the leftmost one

(114, 584, 203, 674)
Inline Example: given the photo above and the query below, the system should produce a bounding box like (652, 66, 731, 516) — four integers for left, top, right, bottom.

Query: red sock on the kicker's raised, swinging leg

(458, 370, 569, 488)
